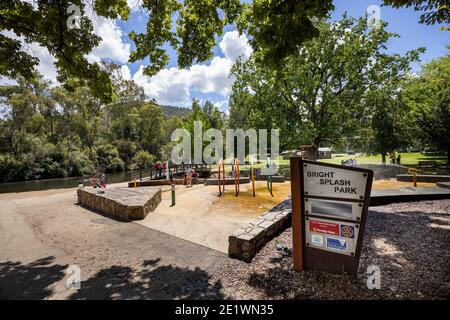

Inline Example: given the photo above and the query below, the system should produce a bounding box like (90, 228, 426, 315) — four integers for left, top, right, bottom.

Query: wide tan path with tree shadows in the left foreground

(0, 189, 228, 299)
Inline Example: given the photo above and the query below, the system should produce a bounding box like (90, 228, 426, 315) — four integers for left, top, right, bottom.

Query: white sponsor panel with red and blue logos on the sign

(305, 217, 359, 255)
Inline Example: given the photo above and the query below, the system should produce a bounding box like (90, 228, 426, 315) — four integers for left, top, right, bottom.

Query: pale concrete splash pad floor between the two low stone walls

(136, 185, 264, 253)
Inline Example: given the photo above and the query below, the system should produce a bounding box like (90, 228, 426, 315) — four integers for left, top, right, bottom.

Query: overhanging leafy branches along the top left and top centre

(0, 0, 333, 102)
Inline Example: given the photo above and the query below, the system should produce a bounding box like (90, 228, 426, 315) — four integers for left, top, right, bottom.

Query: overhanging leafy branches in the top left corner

(0, 0, 129, 101)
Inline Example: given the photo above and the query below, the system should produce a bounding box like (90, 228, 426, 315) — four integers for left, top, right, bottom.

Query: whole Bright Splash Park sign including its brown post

(291, 158, 373, 274)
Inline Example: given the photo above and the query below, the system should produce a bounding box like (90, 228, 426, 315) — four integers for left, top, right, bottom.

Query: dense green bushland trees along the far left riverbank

(0, 64, 224, 182)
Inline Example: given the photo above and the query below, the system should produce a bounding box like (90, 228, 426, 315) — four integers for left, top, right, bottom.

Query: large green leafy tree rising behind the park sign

(230, 16, 423, 158)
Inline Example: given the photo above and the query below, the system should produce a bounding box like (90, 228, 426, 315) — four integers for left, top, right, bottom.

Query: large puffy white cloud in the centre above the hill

(133, 31, 251, 108)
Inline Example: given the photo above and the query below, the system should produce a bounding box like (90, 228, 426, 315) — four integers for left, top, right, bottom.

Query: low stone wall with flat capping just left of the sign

(228, 200, 292, 262)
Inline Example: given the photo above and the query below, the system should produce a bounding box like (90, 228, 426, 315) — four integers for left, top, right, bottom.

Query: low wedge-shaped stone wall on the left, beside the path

(77, 187, 162, 221)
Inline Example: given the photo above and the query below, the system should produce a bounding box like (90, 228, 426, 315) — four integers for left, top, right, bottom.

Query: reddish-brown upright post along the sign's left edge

(290, 157, 303, 271)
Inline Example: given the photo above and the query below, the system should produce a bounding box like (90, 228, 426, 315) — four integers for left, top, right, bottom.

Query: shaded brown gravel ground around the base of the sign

(214, 200, 450, 299)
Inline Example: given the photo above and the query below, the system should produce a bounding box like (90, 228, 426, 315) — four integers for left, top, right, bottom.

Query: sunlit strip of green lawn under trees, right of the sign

(320, 152, 447, 166)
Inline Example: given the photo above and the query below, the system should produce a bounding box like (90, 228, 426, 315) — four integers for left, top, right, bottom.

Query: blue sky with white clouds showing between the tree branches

(0, 0, 450, 111)
